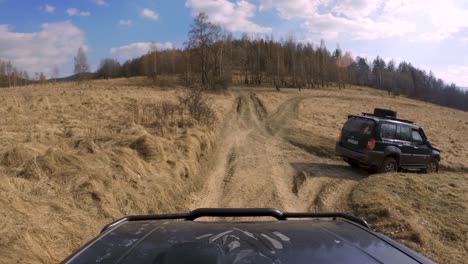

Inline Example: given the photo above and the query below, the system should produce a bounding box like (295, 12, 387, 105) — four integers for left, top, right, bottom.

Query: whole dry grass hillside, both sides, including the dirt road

(0, 79, 468, 263)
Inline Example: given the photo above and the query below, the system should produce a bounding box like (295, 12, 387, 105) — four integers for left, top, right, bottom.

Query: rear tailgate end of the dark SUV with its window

(342, 116, 376, 152)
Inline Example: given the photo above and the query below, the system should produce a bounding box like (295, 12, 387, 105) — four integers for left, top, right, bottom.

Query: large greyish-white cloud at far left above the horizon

(0, 21, 85, 76)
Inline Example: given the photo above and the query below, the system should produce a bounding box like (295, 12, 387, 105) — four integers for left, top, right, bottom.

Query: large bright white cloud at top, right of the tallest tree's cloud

(260, 0, 415, 40)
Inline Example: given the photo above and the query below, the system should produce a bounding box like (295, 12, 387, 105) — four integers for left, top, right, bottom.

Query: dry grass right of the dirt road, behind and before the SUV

(259, 87, 468, 263)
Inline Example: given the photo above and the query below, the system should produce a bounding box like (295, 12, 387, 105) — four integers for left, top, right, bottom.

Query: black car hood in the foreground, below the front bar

(66, 220, 427, 263)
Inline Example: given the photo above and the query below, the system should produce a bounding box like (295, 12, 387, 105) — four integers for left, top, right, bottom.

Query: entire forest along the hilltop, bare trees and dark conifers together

(0, 13, 468, 111)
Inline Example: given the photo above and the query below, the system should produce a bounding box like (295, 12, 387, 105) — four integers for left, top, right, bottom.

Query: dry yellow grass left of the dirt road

(0, 79, 232, 263)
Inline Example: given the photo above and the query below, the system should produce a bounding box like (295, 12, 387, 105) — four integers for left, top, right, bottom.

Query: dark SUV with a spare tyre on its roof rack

(336, 108, 440, 173)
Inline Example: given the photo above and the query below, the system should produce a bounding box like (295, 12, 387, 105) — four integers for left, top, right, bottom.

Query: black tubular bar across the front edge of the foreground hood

(101, 208, 369, 233)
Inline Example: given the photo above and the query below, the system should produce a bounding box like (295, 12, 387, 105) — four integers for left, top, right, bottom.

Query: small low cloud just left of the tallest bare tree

(109, 42, 174, 60)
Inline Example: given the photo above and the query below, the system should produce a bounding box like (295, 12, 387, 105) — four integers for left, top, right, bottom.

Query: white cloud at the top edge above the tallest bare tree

(185, 0, 272, 33)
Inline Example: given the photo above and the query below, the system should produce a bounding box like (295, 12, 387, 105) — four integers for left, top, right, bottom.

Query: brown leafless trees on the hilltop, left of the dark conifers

(98, 14, 354, 90)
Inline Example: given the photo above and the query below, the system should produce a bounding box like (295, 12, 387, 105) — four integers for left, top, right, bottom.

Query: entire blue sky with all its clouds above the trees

(0, 0, 468, 87)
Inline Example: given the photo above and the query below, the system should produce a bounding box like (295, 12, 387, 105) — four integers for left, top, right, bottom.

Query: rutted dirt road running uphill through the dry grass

(191, 92, 365, 212)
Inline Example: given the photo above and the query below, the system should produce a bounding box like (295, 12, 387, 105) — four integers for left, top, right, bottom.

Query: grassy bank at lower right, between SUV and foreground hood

(351, 172, 468, 263)
